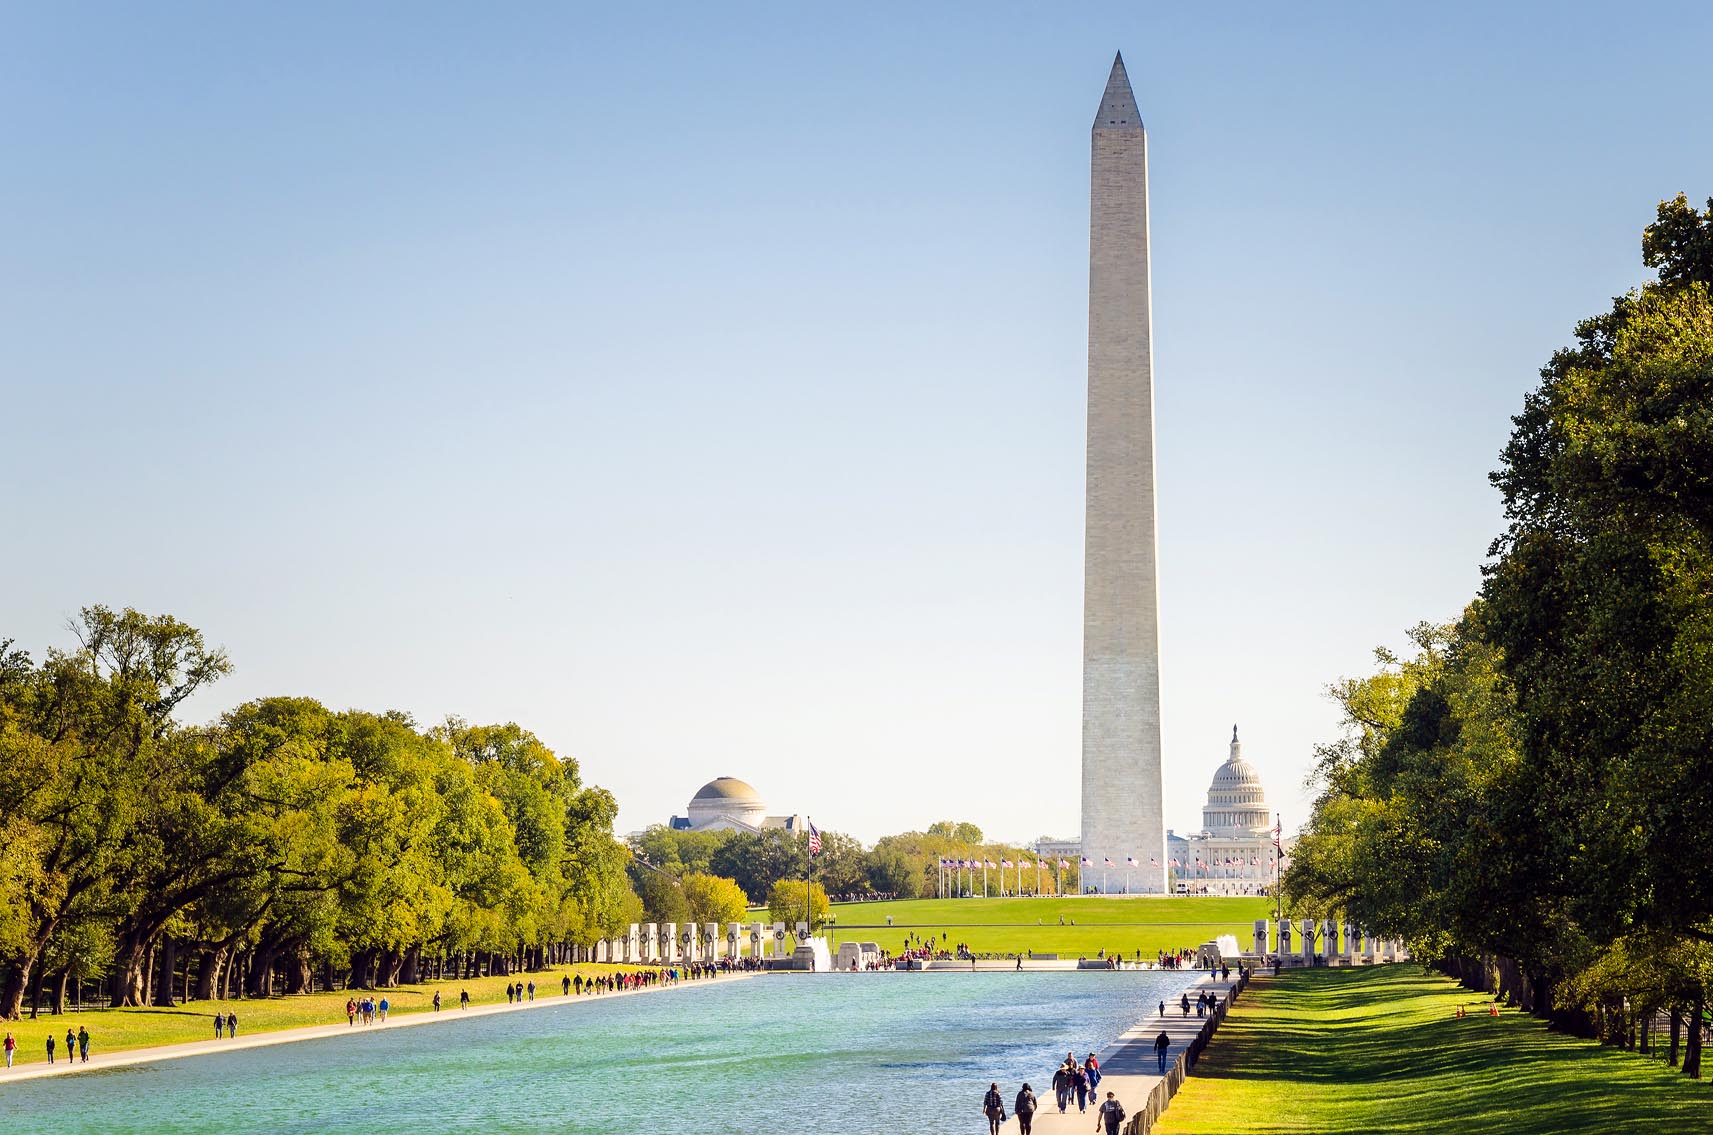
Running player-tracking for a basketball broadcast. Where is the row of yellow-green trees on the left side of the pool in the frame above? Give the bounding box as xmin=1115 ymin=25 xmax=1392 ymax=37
xmin=0 ymin=606 xmax=639 ymax=1017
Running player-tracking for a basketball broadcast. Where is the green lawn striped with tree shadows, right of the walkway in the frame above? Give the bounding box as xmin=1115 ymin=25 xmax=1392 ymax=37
xmin=1155 ymin=966 xmax=1713 ymax=1135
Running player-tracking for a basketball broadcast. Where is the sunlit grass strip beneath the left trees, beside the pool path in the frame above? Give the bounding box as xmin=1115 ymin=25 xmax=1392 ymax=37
xmin=5 ymin=966 xmax=636 ymax=1063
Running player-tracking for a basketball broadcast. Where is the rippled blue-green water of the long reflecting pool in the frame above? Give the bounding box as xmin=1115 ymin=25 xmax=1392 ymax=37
xmin=0 ymin=972 xmax=1194 ymax=1135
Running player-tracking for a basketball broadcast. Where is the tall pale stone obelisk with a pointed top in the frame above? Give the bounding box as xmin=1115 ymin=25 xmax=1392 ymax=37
xmin=1083 ymin=55 xmax=1167 ymax=894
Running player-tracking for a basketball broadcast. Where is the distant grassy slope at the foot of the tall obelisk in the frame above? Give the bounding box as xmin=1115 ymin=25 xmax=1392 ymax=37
xmin=833 ymin=897 xmax=1273 ymax=959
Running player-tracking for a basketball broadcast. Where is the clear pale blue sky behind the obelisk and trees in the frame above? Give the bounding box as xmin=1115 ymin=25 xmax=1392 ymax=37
xmin=0 ymin=3 xmax=1713 ymax=839
